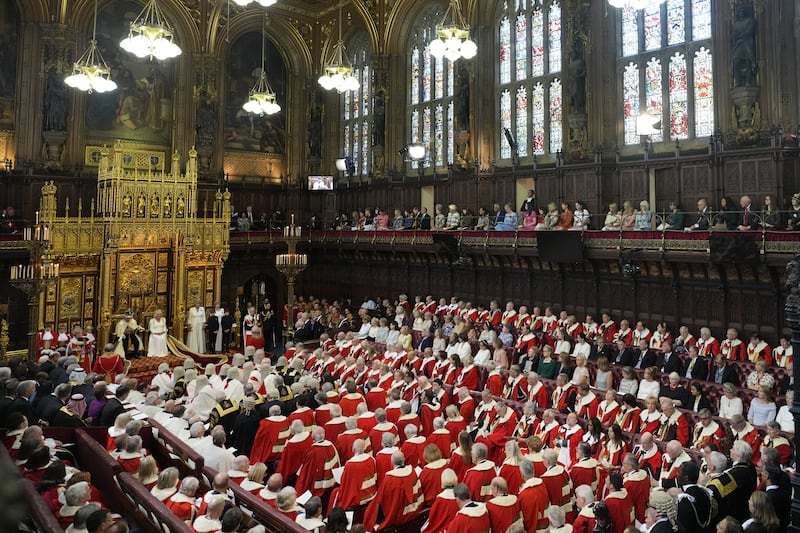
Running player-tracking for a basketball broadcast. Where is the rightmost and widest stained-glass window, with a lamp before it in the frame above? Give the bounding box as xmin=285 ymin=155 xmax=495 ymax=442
xmin=618 ymin=0 xmax=714 ymax=145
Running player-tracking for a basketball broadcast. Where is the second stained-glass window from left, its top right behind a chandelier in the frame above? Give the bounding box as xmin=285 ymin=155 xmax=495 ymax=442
xmin=408 ymin=6 xmax=456 ymax=171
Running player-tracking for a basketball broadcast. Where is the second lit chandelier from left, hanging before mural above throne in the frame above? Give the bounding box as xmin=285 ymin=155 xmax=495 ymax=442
xmin=119 ymin=0 xmax=181 ymax=61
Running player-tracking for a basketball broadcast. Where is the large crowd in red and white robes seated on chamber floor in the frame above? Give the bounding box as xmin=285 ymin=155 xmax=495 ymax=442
xmin=0 ymin=290 xmax=794 ymax=533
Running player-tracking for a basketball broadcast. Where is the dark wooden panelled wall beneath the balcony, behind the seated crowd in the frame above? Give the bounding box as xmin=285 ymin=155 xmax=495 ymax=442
xmin=286 ymin=250 xmax=788 ymax=342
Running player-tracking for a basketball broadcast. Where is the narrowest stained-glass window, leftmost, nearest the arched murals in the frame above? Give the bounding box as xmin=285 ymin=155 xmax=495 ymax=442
xmin=342 ymin=33 xmax=372 ymax=176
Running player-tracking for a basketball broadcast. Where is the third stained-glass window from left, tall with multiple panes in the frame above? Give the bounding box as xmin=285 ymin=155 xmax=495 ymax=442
xmin=497 ymin=0 xmax=564 ymax=160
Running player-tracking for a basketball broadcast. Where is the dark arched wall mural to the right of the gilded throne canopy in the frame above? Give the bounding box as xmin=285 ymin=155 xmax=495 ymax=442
xmin=225 ymin=32 xmax=286 ymax=154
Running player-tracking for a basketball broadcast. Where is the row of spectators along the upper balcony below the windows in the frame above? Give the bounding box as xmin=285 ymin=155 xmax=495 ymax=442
xmin=232 ymin=190 xmax=800 ymax=231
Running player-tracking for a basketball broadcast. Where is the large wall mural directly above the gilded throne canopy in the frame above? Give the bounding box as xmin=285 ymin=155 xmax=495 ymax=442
xmin=86 ymin=1 xmax=176 ymax=145
